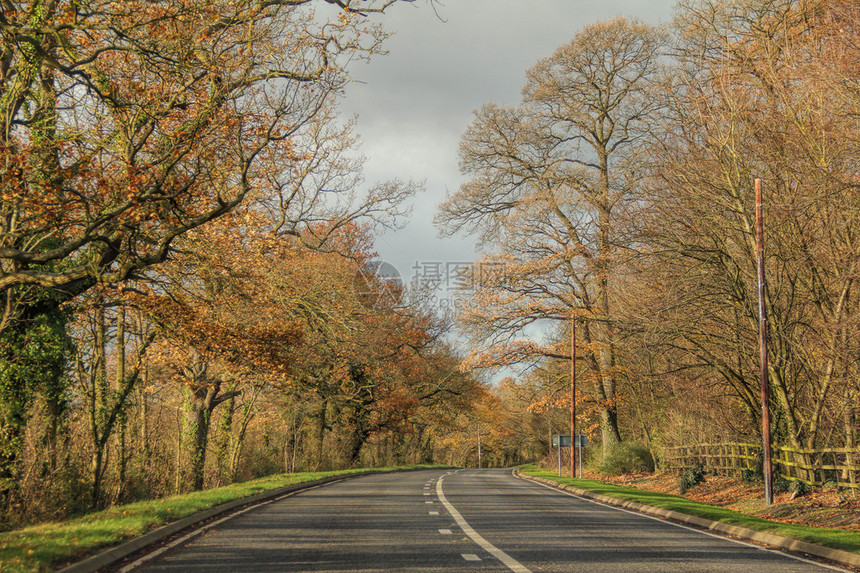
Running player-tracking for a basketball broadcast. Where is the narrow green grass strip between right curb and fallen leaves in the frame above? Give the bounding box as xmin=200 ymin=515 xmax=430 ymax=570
xmin=520 ymin=464 xmax=860 ymax=553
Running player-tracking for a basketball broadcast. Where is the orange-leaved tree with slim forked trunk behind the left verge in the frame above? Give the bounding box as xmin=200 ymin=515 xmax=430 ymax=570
xmin=135 ymin=217 xmax=352 ymax=490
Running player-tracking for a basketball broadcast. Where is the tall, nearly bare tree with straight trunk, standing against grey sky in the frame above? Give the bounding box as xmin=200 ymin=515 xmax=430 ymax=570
xmin=438 ymin=18 xmax=660 ymax=444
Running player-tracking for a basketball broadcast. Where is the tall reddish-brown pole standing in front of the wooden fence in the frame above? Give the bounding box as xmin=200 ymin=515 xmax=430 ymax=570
xmin=755 ymin=179 xmax=773 ymax=505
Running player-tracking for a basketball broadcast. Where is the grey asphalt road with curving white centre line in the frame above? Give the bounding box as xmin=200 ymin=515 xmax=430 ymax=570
xmin=133 ymin=470 xmax=848 ymax=573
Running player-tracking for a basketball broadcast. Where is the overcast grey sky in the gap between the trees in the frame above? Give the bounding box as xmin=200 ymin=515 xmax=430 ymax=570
xmin=343 ymin=0 xmax=674 ymax=288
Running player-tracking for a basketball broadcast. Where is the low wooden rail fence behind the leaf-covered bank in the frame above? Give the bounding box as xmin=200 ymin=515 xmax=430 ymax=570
xmin=659 ymin=442 xmax=860 ymax=491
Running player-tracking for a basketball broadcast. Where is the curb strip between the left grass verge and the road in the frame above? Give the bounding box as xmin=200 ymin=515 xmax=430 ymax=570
xmin=58 ymin=468 xmax=429 ymax=573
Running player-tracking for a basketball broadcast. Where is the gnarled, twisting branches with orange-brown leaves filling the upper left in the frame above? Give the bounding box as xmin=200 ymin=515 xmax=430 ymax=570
xmin=0 ymin=0 xmax=408 ymax=329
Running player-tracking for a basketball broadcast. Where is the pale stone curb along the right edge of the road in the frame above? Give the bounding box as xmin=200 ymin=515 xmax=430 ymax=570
xmin=514 ymin=469 xmax=860 ymax=567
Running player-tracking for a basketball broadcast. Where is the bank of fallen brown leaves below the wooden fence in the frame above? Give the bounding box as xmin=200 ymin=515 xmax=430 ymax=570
xmin=596 ymin=474 xmax=860 ymax=530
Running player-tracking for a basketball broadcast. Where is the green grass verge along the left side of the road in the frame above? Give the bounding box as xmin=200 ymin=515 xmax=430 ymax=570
xmin=0 ymin=466 xmax=440 ymax=573
